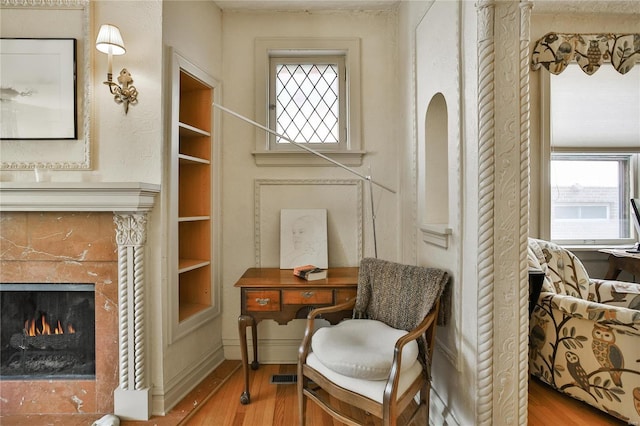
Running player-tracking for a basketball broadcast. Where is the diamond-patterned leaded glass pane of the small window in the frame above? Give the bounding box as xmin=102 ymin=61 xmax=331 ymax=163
xmin=276 ymin=64 xmax=339 ymax=143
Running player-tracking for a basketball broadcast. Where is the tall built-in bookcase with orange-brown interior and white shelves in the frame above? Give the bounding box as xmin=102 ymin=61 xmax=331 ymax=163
xmin=169 ymin=53 xmax=215 ymax=330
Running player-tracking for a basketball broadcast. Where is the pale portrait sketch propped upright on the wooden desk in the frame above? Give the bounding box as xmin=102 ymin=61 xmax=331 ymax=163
xmin=280 ymin=209 xmax=329 ymax=269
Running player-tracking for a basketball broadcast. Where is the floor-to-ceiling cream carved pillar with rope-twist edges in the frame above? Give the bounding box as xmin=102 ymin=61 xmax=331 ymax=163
xmin=476 ymin=0 xmax=531 ymax=425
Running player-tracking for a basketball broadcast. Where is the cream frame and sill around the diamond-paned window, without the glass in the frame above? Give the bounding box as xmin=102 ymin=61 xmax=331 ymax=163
xmin=253 ymin=38 xmax=365 ymax=166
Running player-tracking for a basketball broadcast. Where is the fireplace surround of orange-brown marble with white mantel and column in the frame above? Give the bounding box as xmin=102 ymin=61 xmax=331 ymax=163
xmin=0 ymin=182 xmax=160 ymax=420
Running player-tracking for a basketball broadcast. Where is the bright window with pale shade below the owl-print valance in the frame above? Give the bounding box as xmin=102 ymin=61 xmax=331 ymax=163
xmin=542 ymin=64 xmax=640 ymax=245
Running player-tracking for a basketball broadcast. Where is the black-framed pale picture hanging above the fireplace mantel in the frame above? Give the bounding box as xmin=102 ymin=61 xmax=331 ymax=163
xmin=0 ymin=38 xmax=78 ymax=140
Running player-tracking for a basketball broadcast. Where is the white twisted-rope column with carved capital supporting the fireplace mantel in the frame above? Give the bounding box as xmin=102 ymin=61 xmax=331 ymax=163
xmin=113 ymin=213 xmax=151 ymax=420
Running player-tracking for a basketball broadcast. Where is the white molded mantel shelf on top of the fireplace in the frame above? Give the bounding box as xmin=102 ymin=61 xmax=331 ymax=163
xmin=0 ymin=182 xmax=160 ymax=212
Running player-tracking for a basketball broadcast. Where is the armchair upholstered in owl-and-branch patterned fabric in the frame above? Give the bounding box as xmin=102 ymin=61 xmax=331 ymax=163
xmin=528 ymin=238 xmax=640 ymax=424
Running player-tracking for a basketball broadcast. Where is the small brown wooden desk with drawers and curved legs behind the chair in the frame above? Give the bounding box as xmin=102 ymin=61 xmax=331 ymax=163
xmin=235 ymin=267 xmax=358 ymax=404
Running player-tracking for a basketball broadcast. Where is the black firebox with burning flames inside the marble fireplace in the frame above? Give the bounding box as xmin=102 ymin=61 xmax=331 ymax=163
xmin=0 ymin=284 xmax=95 ymax=380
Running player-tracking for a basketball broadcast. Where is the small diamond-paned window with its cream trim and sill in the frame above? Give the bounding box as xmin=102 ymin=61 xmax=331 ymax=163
xmin=253 ymin=38 xmax=364 ymax=166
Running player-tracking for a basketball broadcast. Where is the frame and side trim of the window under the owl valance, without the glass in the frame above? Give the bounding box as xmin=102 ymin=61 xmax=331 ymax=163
xmin=540 ymin=66 xmax=640 ymax=248
